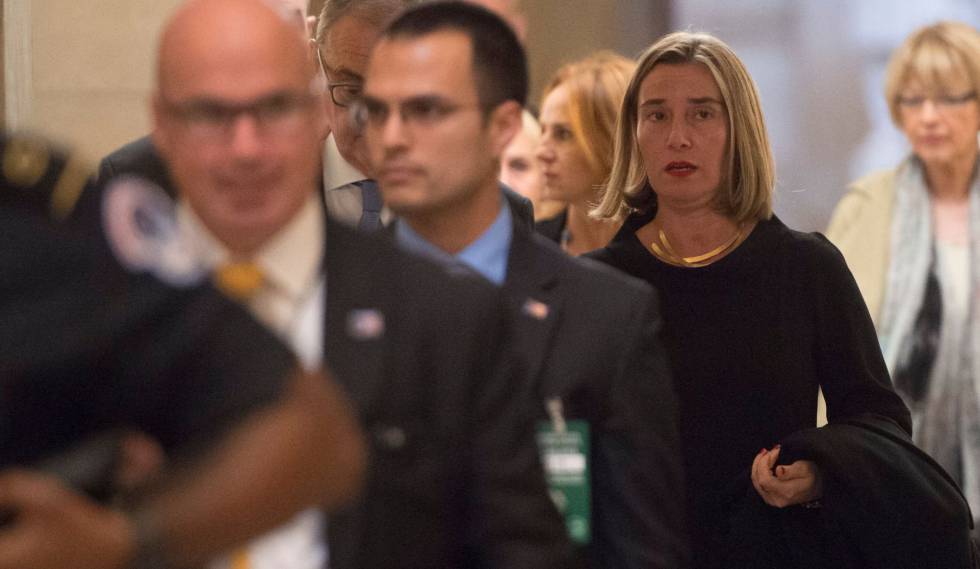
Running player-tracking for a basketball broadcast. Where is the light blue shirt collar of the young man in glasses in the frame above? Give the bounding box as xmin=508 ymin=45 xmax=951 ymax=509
xmin=395 ymin=196 xmax=513 ymax=285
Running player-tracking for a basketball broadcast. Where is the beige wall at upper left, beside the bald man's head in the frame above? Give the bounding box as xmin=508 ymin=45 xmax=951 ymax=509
xmin=3 ymin=0 xmax=179 ymax=160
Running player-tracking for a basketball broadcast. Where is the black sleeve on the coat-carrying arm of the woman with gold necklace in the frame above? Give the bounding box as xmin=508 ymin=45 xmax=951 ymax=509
xmin=808 ymin=234 xmax=912 ymax=434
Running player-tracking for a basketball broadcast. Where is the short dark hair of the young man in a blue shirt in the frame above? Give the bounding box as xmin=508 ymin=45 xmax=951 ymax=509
xmin=381 ymin=1 xmax=528 ymax=111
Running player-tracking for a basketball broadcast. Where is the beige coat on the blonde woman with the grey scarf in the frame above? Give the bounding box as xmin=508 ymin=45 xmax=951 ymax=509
xmin=827 ymin=170 xmax=895 ymax=327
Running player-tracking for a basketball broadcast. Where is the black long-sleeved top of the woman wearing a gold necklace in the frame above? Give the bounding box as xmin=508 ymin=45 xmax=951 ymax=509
xmin=590 ymin=212 xmax=911 ymax=566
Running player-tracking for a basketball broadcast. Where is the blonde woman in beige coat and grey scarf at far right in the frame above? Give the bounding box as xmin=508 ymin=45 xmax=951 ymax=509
xmin=827 ymin=22 xmax=980 ymax=537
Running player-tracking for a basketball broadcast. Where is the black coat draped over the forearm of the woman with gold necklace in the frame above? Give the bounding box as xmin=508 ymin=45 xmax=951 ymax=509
xmin=769 ymin=414 xmax=973 ymax=569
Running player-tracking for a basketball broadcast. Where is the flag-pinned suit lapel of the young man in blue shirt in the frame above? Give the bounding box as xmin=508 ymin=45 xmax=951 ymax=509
xmin=504 ymin=207 xmax=563 ymax=385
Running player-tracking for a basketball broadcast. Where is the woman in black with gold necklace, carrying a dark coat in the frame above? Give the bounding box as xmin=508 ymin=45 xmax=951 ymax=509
xmin=590 ymin=32 xmax=971 ymax=569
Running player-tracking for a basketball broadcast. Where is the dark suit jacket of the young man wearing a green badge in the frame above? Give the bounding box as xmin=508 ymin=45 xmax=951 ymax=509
xmin=504 ymin=193 xmax=687 ymax=569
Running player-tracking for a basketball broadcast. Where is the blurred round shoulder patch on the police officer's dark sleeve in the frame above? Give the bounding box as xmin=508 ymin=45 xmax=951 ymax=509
xmin=102 ymin=176 xmax=207 ymax=287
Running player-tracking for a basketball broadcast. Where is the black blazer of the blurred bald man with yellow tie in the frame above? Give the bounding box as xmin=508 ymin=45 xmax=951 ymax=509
xmin=324 ymin=222 xmax=571 ymax=569
